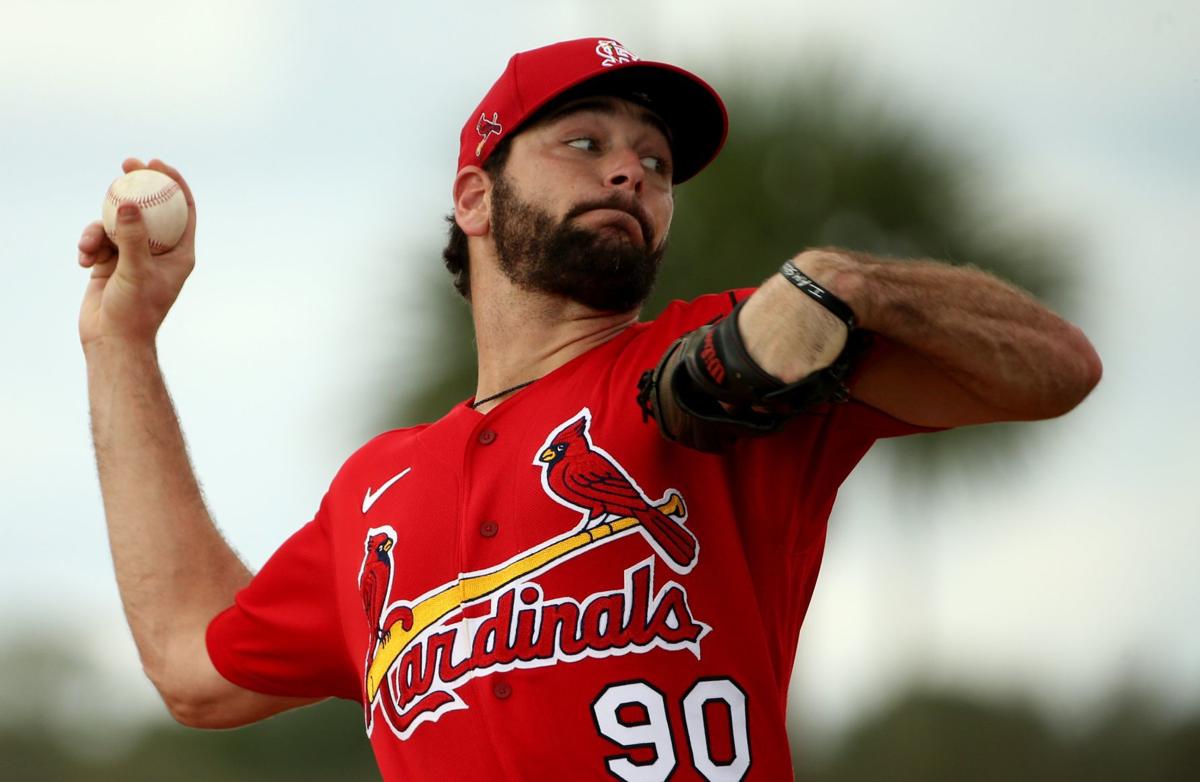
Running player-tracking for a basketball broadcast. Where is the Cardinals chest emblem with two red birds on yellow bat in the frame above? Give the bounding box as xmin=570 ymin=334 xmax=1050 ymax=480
xmin=359 ymin=408 xmax=712 ymax=741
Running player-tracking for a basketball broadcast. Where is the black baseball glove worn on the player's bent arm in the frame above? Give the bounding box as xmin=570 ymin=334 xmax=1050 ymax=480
xmin=638 ymin=302 xmax=866 ymax=452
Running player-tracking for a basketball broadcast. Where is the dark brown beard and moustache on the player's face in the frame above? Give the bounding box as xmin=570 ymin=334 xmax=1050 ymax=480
xmin=492 ymin=176 xmax=666 ymax=312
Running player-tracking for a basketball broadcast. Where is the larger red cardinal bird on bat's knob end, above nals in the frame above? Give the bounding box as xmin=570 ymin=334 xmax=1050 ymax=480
xmin=534 ymin=408 xmax=700 ymax=573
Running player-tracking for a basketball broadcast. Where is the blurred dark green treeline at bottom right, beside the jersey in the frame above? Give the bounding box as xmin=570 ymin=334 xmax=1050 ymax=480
xmin=793 ymin=684 xmax=1200 ymax=782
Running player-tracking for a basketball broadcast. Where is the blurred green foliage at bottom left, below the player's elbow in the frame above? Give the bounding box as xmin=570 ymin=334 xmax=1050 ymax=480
xmin=0 ymin=627 xmax=379 ymax=782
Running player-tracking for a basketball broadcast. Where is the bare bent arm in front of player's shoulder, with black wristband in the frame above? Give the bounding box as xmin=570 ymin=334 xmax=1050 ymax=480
xmin=742 ymin=251 xmax=1100 ymax=426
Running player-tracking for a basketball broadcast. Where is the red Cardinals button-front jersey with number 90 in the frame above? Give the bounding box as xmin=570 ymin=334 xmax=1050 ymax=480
xmin=208 ymin=291 xmax=920 ymax=782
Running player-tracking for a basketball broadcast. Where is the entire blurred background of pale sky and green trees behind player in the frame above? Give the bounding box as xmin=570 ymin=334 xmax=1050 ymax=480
xmin=0 ymin=0 xmax=1200 ymax=782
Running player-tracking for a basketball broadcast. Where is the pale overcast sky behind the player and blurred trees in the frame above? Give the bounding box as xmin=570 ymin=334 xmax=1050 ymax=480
xmin=0 ymin=0 xmax=1200 ymax=724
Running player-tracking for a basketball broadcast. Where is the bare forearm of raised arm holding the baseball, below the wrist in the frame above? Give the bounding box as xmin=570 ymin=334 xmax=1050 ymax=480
xmin=85 ymin=341 xmax=250 ymax=690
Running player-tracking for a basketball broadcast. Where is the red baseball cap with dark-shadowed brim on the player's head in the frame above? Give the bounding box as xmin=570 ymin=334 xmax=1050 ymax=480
xmin=458 ymin=38 xmax=728 ymax=184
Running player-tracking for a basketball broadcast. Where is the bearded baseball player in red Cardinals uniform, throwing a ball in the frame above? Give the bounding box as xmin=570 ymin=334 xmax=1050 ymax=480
xmin=79 ymin=38 xmax=1100 ymax=781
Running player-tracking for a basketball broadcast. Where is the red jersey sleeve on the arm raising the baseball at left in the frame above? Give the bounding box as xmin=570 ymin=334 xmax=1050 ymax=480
xmin=206 ymin=494 xmax=362 ymax=700
